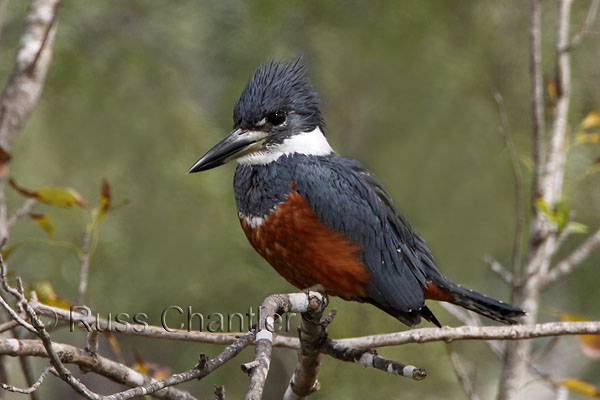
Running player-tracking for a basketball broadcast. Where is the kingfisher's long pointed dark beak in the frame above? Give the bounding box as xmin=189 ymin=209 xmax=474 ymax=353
xmin=187 ymin=129 xmax=267 ymax=174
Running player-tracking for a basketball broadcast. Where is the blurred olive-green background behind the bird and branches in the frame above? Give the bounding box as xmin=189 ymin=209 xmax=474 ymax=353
xmin=0 ymin=0 xmax=600 ymax=399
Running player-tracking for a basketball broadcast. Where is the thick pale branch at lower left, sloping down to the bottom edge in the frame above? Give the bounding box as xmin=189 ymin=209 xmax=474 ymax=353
xmin=0 ymin=338 xmax=194 ymax=400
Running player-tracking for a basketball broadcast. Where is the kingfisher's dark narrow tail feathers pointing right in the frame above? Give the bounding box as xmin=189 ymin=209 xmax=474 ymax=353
xmin=433 ymin=278 xmax=525 ymax=324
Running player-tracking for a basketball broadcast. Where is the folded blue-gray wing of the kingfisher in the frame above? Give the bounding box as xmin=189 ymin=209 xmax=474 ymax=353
xmin=293 ymin=155 xmax=437 ymax=325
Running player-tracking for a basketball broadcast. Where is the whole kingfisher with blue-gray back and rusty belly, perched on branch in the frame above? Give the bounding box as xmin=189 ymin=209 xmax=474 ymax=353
xmin=188 ymin=56 xmax=524 ymax=327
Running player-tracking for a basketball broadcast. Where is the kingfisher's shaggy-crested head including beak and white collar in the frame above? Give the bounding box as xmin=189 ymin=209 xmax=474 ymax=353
xmin=188 ymin=57 xmax=331 ymax=173
